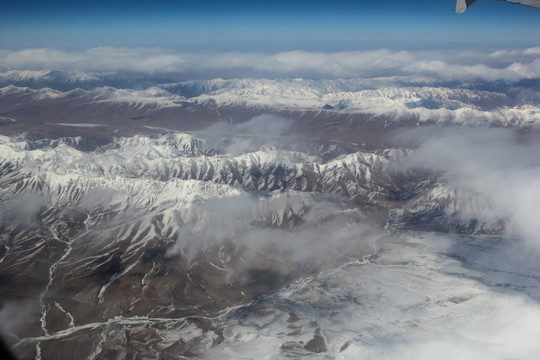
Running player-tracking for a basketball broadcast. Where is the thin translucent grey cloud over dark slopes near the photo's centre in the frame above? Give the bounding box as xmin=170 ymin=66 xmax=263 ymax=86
xmin=168 ymin=193 xmax=381 ymax=270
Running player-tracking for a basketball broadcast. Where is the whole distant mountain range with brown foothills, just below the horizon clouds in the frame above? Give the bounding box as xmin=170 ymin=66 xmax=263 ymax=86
xmin=0 ymin=70 xmax=540 ymax=142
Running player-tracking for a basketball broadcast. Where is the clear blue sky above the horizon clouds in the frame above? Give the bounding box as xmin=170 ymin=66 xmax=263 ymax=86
xmin=0 ymin=0 xmax=540 ymax=52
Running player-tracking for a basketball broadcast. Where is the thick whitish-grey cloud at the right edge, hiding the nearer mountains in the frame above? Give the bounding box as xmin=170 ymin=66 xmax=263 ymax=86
xmin=394 ymin=128 xmax=540 ymax=248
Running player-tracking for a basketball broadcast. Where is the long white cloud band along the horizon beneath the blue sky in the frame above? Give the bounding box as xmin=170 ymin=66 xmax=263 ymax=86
xmin=0 ymin=47 xmax=540 ymax=81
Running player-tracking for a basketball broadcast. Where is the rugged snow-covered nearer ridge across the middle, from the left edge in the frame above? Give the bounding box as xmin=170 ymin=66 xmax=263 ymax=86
xmin=0 ymin=133 xmax=395 ymax=207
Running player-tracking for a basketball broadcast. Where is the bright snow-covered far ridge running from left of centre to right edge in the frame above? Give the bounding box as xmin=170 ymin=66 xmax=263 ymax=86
xmin=158 ymin=79 xmax=540 ymax=126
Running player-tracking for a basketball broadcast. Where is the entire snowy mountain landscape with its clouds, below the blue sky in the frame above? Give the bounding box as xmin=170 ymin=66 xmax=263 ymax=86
xmin=0 ymin=48 xmax=540 ymax=360
